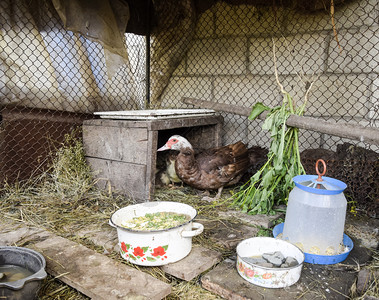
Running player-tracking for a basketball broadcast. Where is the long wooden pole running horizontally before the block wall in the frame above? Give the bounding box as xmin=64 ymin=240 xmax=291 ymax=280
xmin=182 ymin=98 xmax=379 ymax=145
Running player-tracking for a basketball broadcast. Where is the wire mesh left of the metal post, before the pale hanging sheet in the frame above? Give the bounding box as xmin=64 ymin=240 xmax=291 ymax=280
xmin=0 ymin=1 xmax=141 ymax=181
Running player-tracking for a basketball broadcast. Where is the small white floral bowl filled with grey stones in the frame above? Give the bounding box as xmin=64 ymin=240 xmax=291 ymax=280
xmin=236 ymin=237 xmax=304 ymax=288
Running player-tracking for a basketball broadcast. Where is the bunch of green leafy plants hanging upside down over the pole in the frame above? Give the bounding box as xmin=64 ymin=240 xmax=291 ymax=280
xmin=232 ymin=39 xmax=313 ymax=214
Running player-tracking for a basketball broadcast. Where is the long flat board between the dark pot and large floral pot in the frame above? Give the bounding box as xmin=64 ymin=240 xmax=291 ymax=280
xmin=33 ymin=234 xmax=171 ymax=300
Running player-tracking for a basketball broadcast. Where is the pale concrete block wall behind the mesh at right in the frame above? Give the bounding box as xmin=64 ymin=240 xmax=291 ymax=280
xmin=162 ymin=0 xmax=379 ymax=149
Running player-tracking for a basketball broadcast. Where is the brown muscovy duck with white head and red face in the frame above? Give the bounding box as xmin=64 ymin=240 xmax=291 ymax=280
xmin=158 ymin=135 xmax=267 ymax=201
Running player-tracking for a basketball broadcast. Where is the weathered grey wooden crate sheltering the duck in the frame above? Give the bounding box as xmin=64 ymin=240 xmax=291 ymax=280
xmin=83 ymin=115 xmax=223 ymax=202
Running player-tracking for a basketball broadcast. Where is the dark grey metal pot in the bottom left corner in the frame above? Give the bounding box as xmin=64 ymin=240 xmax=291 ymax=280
xmin=0 ymin=246 xmax=47 ymax=300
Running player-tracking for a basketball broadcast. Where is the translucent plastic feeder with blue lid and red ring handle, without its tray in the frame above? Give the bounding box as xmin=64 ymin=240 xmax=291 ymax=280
xmin=282 ymin=160 xmax=347 ymax=255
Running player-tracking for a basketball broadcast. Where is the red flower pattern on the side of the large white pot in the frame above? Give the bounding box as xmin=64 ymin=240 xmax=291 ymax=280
xmin=119 ymin=242 xmax=168 ymax=262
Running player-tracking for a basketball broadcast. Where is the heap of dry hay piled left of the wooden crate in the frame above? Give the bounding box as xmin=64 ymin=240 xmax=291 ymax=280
xmin=0 ymin=135 xmax=130 ymax=237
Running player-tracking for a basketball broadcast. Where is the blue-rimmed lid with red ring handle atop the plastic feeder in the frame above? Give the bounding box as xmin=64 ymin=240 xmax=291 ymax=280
xmin=293 ymin=159 xmax=347 ymax=195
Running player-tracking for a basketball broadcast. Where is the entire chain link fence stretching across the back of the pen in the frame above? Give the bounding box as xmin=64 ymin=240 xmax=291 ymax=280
xmin=0 ymin=0 xmax=379 ymax=211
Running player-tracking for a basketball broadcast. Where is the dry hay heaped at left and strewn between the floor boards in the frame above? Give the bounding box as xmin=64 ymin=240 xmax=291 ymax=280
xmin=0 ymin=133 xmax=232 ymax=300
